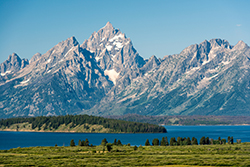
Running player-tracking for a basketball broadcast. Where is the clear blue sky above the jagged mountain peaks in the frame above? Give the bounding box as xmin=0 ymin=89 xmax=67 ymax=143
xmin=0 ymin=0 xmax=250 ymax=63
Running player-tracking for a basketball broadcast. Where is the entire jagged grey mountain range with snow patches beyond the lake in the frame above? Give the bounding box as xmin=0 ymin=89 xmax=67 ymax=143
xmin=0 ymin=22 xmax=250 ymax=118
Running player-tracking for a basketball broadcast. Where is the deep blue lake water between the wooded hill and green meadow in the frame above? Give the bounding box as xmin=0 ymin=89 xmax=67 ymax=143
xmin=0 ymin=126 xmax=250 ymax=150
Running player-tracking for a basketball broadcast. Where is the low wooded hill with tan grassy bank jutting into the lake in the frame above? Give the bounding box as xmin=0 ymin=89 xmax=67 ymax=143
xmin=0 ymin=115 xmax=167 ymax=133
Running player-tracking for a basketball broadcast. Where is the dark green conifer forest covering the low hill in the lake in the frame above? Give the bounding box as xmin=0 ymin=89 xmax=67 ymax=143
xmin=0 ymin=115 xmax=167 ymax=133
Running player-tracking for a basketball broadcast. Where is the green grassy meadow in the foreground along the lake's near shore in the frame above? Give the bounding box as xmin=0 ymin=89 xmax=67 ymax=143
xmin=0 ymin=143 xmax=250 ymax=167
